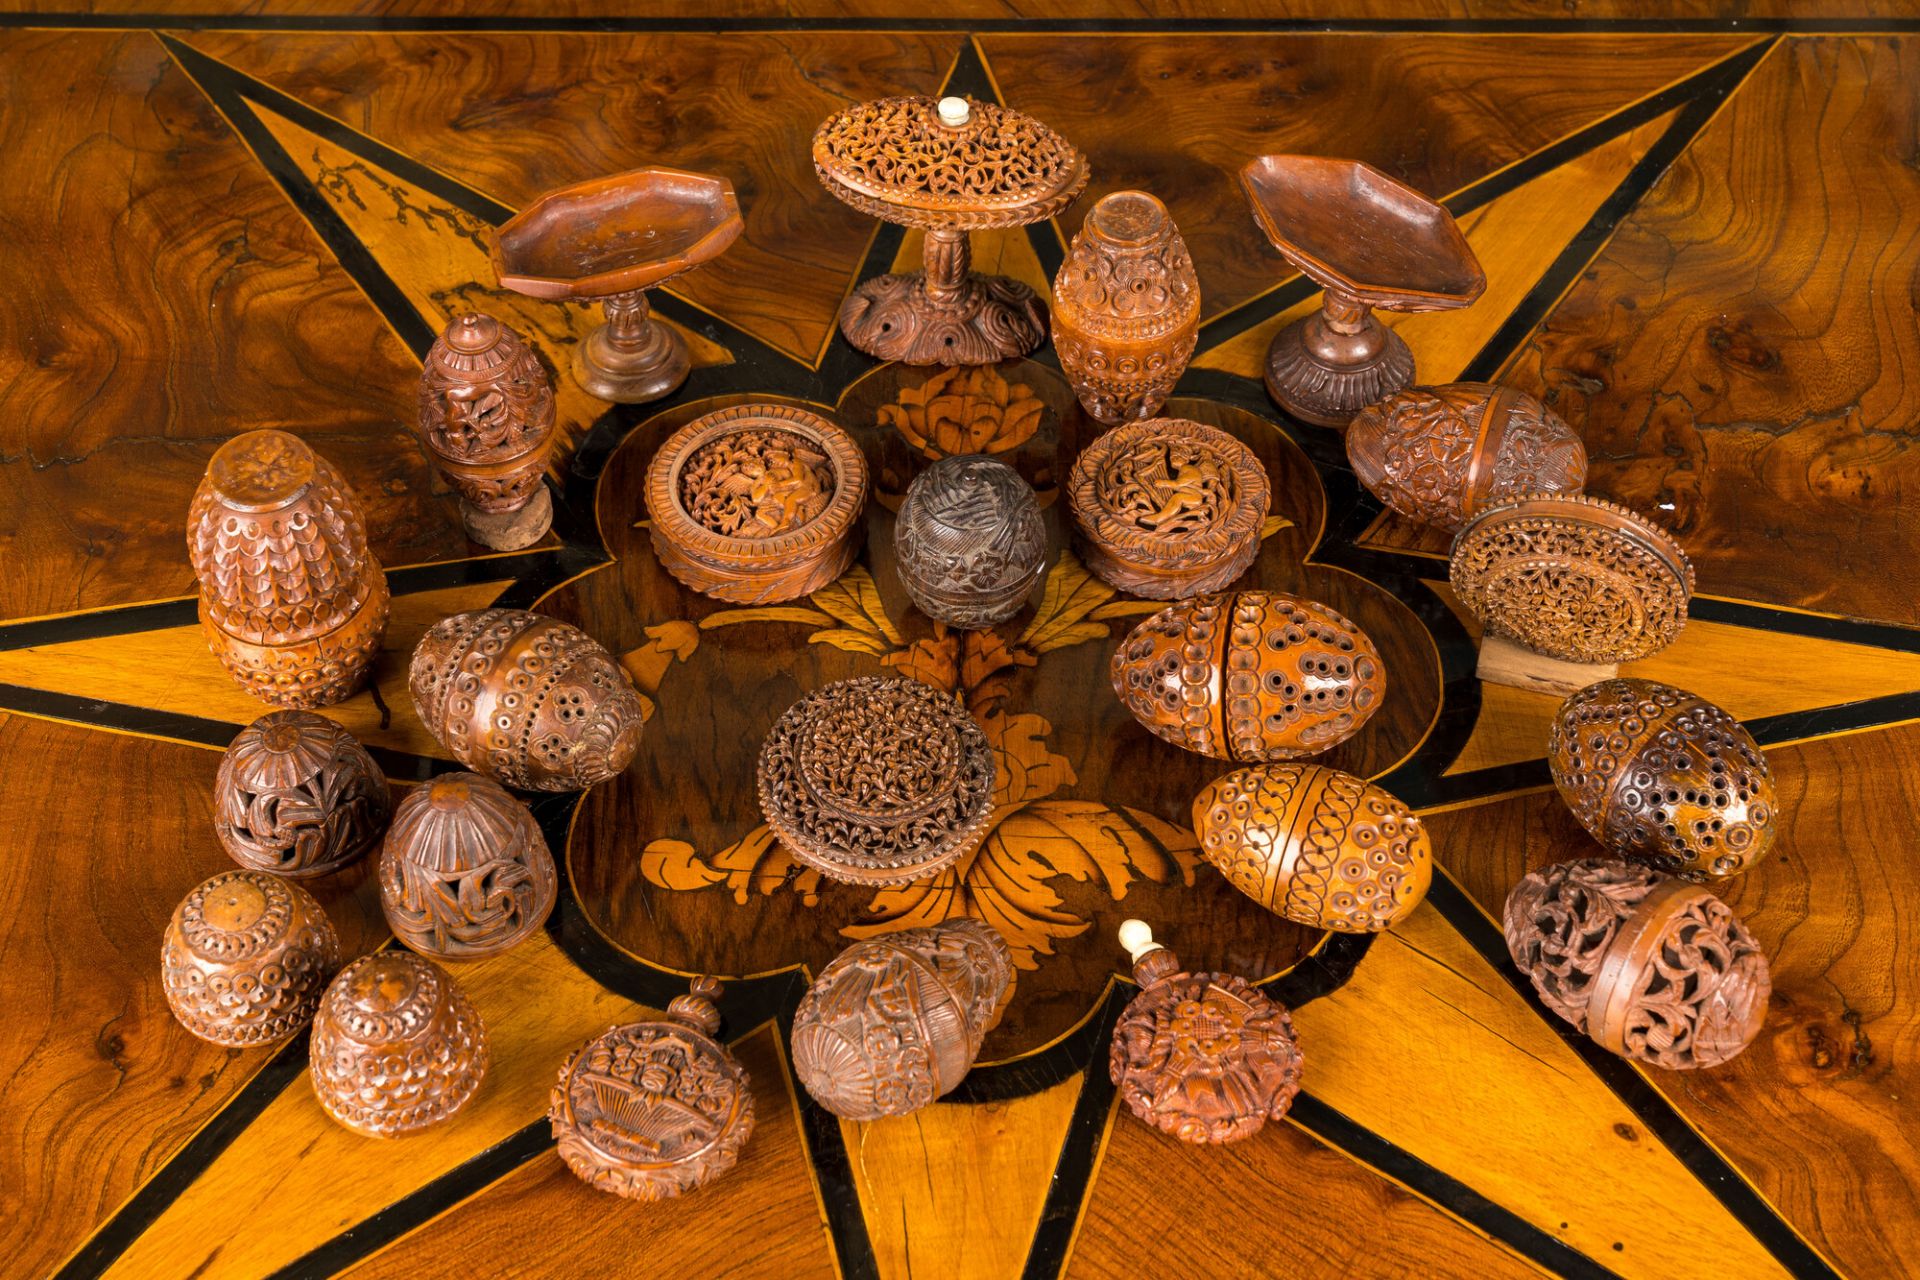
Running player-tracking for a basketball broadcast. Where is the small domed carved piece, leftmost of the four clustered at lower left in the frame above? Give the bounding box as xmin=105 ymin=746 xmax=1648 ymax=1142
xmin=159 ymin=871 xmax=340 ymax=1050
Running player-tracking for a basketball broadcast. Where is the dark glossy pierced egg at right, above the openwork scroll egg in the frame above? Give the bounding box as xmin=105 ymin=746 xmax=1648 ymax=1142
xmin=1548 ymin=677 xmax=1778 ymax=881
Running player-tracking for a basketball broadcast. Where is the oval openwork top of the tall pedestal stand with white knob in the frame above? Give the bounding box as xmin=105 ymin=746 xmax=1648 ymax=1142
xmin=814 ymin=98 xmax=1087 ymax=230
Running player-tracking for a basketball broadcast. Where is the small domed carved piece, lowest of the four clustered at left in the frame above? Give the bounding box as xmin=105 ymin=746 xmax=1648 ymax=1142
xmin=309 ymin=950 xmax=490 ymax=1138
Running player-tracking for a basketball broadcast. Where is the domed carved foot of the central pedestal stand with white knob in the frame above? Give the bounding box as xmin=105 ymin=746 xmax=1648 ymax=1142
xmin=841 ymin=271 xmax=1046 ymax=365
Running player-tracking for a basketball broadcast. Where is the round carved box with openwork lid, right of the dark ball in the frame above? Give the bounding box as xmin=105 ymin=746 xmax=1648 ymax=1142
xmin=1068 ymin=418 xmax=1269 ymax=601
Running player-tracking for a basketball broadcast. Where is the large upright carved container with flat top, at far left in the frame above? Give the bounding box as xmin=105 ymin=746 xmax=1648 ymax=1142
xmin=186 ymin=432 xmax=390 ymax=708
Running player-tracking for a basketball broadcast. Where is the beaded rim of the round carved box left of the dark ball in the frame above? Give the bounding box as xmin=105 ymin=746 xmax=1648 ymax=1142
xmin=647 ymin=405 xmax=866 ymax=578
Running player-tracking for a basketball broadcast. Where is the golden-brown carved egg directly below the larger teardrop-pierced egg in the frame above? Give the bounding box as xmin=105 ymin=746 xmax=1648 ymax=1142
xmin=1194 ymin=764 xmax=1434 ymax=933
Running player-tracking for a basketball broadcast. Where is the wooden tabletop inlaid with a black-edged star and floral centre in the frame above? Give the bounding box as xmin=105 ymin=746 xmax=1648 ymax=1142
xmin=0 ymin=0 xmax=1920 ymax=1280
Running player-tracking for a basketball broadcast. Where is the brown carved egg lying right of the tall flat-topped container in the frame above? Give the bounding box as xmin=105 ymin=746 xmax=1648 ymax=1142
xmin=407 ymin=608 xmax=645 ymax=791
